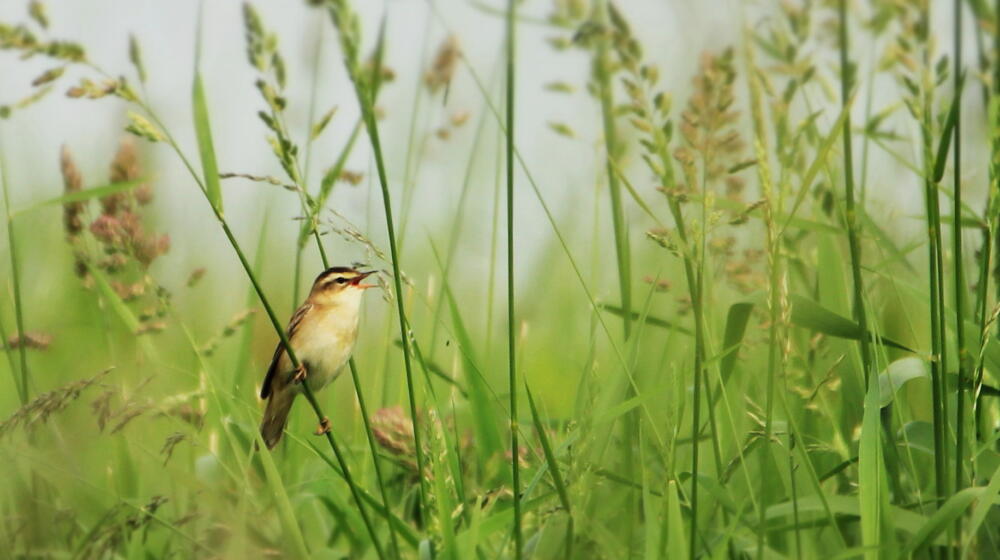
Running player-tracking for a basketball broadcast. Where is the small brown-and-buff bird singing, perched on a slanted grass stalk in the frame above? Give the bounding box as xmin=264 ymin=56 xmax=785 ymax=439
xmin=260 ymin=266 xmax=376 ymax=449
